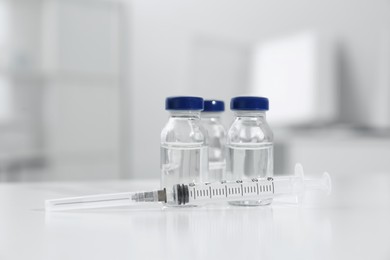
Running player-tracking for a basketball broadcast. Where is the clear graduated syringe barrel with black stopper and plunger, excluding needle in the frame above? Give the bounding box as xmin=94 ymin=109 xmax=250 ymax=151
xmin=168 ymin=172 xmax=331 ymax=206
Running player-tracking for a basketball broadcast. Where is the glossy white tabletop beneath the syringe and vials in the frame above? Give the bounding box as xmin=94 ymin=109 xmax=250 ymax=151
xmin=0 ymin=174 xmax=390 ymax=260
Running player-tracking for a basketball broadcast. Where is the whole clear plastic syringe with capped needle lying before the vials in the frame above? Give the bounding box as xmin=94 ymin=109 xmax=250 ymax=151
xmin=45 ymin=164 xmax=331 ymax=211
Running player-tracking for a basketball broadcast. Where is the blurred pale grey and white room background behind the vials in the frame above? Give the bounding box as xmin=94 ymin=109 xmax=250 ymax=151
xmin=0 ymin=0 xmax=390 ymax=182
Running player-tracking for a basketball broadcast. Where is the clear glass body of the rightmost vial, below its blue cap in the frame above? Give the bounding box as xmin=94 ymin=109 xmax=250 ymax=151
xmin=227 ymin=111 xmax=273 ymax=206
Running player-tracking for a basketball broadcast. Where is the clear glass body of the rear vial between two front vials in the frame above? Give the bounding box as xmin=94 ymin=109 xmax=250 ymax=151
xmin=201 ymin=112 xmax=226 ymax=182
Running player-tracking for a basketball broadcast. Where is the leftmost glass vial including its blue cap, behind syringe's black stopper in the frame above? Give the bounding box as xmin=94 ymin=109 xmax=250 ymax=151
xmin=160 ymin=96 xmax=208 ymax=206
